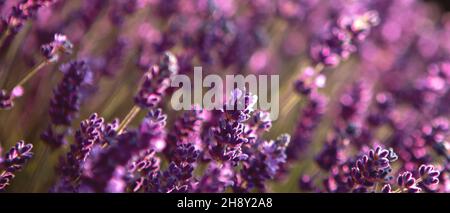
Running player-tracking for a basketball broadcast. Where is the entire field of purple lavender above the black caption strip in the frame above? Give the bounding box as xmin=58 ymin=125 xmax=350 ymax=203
xmin=0 ymin=0 xmax=450 ymax=193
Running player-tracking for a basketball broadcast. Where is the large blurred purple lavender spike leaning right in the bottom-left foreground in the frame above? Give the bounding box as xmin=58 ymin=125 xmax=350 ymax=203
xmin=82 ymin=109 xmax=166 ymax=192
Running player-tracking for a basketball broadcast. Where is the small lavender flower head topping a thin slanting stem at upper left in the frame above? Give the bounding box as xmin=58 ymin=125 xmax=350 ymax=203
xmin=41 ymin=34 xmax=73 ymax=62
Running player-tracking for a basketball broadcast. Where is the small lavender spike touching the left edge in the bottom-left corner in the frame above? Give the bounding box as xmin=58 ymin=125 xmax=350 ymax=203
xmin=0 ymin=141 xmax=33 ymax=191
